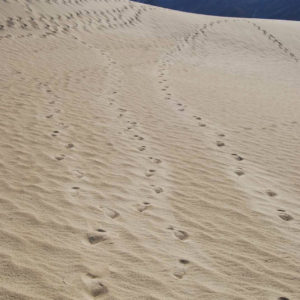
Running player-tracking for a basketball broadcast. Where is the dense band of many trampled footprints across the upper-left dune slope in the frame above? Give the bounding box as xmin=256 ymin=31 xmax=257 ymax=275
xmin=0 ymin=1 xmax=147 ymax=40
